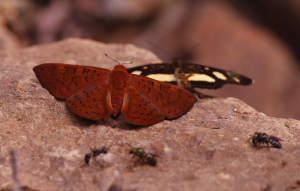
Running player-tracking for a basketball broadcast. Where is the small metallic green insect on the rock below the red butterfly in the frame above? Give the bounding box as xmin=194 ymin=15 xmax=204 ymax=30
xmin=129 ymin=148 xmax=157 ymax=166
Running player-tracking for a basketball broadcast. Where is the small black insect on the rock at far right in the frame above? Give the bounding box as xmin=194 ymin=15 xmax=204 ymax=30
xmin=251 ymin=132 xmax=282 ymax=149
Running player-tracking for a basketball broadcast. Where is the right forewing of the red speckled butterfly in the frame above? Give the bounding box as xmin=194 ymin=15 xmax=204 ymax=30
xmin=123 ymin=75 xmax=197 ymax=119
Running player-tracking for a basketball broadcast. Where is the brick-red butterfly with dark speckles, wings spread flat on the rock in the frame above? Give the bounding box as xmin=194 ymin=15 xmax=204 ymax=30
xmin=33 ymin=63 xmax=197 ymax=125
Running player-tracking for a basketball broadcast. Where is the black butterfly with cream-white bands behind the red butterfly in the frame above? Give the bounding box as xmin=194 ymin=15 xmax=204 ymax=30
xmin=127 ymin=59 xmax=254 ymax=98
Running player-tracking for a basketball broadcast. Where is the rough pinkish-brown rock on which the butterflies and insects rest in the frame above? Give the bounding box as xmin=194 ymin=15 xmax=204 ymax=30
xmin=0 ymin=39 xmax=300 ymax=191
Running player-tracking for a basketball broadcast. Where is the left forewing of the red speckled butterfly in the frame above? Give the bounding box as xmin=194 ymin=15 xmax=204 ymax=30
xmin=33 ymin=63 xmax=111 ymax=99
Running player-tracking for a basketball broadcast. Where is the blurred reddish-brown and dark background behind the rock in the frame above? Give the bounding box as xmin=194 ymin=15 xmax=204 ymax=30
xmin=0 ymin=0 xmax=300 ymax=119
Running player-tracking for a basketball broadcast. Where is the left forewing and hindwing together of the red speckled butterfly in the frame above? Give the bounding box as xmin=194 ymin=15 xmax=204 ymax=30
xmin=33 ymin=63 xmax=112 ymax=120
